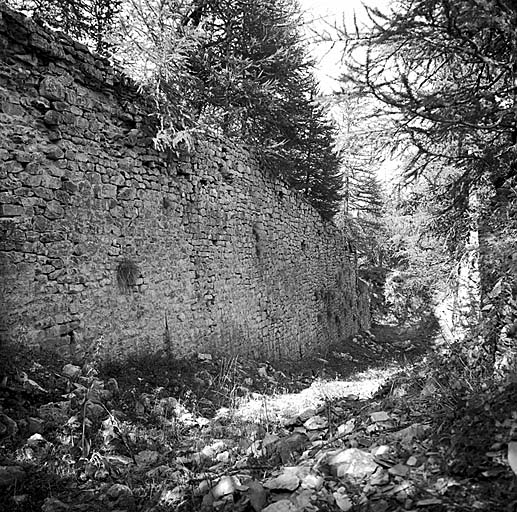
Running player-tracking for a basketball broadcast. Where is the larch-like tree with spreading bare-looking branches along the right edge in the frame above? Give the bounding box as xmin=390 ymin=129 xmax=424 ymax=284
xmin=338 ymin=0 xmax=517 ymax=374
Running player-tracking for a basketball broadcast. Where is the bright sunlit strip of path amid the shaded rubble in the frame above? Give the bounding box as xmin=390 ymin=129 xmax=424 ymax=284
xmin=234 ymin=367 xmax=400 ymax=424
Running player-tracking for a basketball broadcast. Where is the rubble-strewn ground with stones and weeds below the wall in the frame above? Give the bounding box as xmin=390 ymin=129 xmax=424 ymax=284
xmin=0 ymin=325 xmax=517 ymax=512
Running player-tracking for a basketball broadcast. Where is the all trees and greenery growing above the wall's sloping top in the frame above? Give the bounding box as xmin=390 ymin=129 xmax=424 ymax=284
xmin=9 ymin=0 xmax=342 ymax=220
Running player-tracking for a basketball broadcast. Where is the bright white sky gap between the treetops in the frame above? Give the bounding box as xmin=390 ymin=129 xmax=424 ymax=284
xmin=299 ymin=0 xmax=390 ymax=93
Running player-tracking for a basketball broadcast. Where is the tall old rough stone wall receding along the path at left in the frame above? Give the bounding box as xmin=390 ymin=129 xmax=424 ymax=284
xmin=0 ymin=7 xmax=368 ymax=364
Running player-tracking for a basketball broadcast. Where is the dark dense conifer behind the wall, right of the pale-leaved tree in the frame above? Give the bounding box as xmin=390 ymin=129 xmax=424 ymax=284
xmin=153 ymin=0 xmax=342 ymax=219
